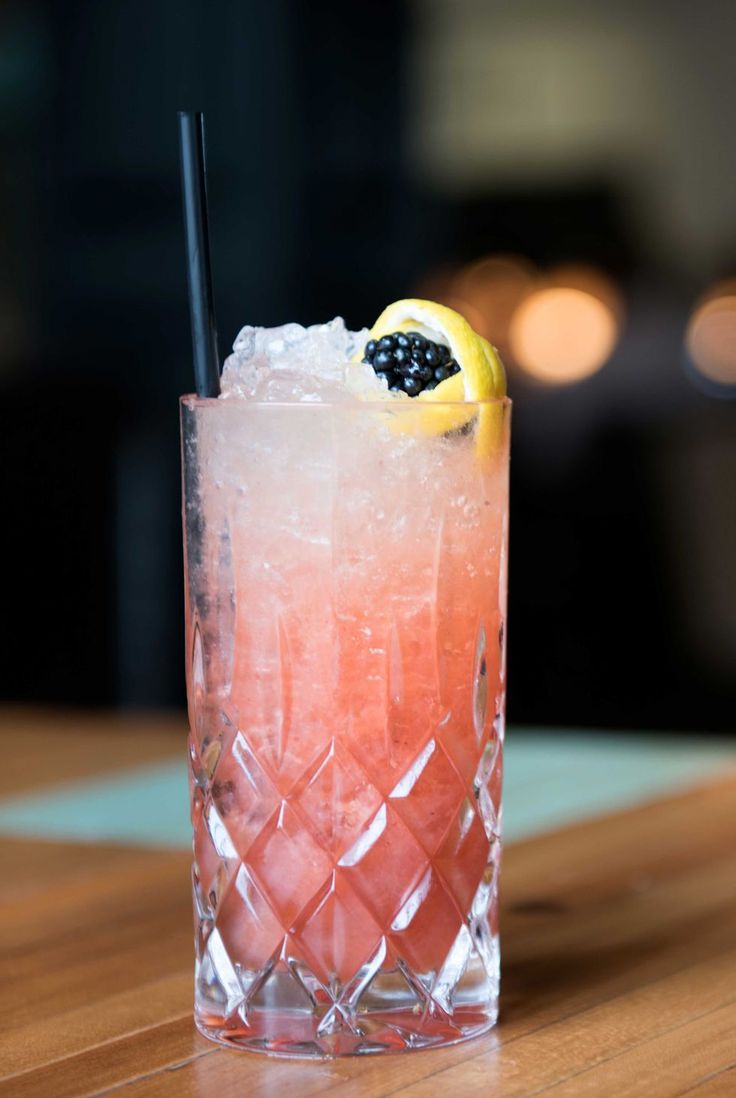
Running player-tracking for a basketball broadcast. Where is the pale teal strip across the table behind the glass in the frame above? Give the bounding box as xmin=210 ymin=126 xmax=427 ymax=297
xmin=0 ymin=728 xmax=736 ymax=849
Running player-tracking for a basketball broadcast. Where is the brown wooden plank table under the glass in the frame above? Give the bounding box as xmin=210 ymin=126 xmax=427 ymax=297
xmin=0 ymin=715 xmax=736 ymax=1098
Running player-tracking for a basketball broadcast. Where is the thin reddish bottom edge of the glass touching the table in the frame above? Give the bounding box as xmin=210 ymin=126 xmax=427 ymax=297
xmin=194 ymin=1008 xmax=498 ymax=1060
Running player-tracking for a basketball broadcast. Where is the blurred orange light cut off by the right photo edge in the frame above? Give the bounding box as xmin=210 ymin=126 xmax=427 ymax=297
xmin=685 ymin=279 xmax=736 ymax=385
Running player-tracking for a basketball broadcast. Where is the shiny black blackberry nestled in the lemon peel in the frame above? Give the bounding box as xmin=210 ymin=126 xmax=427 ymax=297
xmin=363 ymin=332 xmax=460 ymax=396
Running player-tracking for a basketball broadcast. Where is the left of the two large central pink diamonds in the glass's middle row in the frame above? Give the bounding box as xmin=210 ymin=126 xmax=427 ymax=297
xmin=247 ymin=800 xmax=332 ymax=928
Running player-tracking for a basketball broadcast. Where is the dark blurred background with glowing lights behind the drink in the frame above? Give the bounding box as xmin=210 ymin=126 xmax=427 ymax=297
xmin=0 ymin=0 xmax=736 ymax=731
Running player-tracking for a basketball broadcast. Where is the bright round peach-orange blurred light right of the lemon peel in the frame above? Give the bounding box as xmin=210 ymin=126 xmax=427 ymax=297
xmin=510 ymin=285 xmax=618 ymax=384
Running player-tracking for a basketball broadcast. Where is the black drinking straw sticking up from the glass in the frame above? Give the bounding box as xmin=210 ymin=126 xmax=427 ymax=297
xmin=179 ymin=111 xmax=220 ymax=396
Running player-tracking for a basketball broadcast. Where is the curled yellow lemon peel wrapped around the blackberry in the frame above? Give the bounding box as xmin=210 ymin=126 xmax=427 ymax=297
xmin=358 ymin=298 xmax=506 ymax=455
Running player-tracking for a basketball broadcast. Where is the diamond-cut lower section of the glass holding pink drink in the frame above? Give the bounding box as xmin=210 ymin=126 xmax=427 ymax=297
xmin=194 ymin=698 xmax=501 ymax=1054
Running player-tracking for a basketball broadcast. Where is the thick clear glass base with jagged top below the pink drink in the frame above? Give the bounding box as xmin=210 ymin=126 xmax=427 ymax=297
xmin=194 ymin=923 xmax=499 ymax=1060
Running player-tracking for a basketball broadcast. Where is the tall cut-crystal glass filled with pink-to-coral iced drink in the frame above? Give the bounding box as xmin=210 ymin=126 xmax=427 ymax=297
xmin=181 ymin=397 xmax=510 ymax=1057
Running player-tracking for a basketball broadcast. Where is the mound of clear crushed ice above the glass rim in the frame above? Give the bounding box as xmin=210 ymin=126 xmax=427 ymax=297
xmin=221 ymin=316 xmax=406 ymax=402
